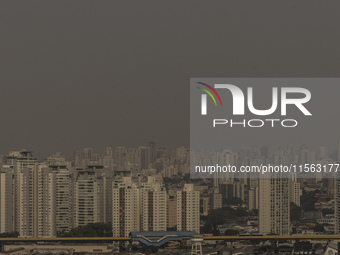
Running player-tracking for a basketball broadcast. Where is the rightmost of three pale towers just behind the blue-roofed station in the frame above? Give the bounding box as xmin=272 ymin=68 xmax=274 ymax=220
xmin=177 ymin=184 xmax=200 ymax=233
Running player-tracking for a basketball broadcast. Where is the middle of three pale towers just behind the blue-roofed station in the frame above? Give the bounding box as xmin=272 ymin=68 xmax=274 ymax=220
xmin=141 ymin=176 xmax=167 ymax=231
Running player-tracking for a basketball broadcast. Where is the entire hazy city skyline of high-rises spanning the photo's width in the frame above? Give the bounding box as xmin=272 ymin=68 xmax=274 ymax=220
xmin=0 ymin=142 xmax=339 ymax=246
